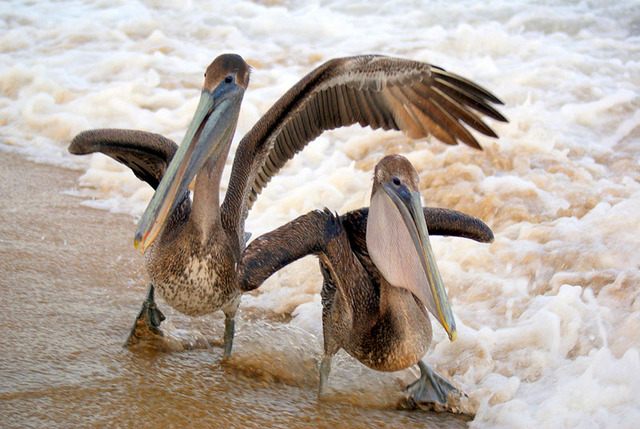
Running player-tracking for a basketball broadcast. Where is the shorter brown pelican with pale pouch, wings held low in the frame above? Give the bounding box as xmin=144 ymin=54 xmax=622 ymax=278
xmin=238 ymin=155 xmax=493 ymax=407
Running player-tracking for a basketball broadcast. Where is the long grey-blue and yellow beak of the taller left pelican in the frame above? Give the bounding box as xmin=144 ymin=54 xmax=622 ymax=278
xmin=133 ymin=84 xmax=244 ymax=253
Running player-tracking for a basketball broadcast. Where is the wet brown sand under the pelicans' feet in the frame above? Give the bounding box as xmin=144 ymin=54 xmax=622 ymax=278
xmin=0 ymin=152 xmax=466 ymax=428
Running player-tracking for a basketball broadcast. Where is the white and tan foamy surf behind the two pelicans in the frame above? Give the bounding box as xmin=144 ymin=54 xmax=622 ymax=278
xmin=0 ymin=0 xmax=640 ymax=427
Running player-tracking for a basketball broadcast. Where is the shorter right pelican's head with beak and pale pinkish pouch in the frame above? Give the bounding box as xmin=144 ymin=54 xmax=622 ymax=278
xmin=366 ymin=155 xmax=456 ymax=341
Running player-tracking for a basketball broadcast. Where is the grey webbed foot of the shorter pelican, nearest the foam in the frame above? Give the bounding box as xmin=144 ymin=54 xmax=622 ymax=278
xmin=405 ymin=360 xmax=467 ymax=412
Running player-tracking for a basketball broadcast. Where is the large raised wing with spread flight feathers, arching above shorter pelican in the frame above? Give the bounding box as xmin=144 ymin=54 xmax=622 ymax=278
xmin=223 ymin=55 xmax=506 ymax=246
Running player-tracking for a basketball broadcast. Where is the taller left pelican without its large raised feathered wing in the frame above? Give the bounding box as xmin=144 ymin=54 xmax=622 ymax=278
xmin=69 ymin=55 xmax=249 ymax=352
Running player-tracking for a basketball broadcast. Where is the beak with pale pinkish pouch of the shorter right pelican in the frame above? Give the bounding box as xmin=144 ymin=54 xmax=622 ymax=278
xmin=367 ymin=182 xmax=457 ymax=341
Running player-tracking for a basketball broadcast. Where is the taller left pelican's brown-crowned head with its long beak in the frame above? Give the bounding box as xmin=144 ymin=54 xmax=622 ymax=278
xmin=134 ymin=54 xmax=249 ymax=253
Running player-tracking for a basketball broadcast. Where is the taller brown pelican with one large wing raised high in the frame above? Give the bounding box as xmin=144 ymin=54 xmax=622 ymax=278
xmin=69 ymin=54 xmax=505 ymax=356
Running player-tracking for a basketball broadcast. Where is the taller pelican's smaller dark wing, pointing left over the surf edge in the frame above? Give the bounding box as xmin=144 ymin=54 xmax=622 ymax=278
xmin=69 ymin=128 xmax=178 ymax=189
